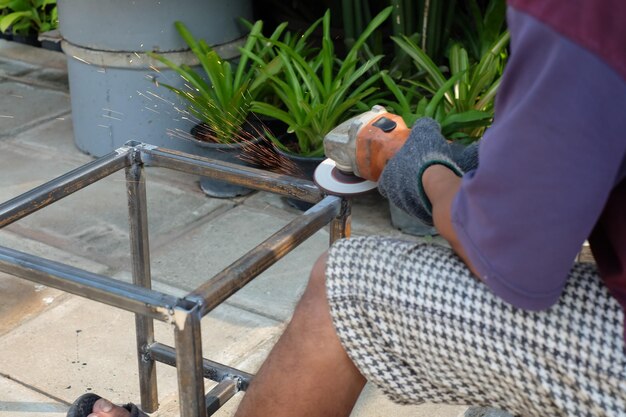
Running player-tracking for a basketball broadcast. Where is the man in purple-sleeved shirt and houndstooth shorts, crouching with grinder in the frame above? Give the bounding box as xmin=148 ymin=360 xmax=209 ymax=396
xmin=68 ymin=0 xmax=626 ymax=417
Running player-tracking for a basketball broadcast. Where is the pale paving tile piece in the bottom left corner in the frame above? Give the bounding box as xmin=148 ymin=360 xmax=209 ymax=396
xmin=0 ymin=376 xmax=68 ymax=417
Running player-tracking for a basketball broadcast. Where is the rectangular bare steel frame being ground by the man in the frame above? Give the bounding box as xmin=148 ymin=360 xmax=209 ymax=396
xmin=0 ymin=142 xmax=351 ymax=417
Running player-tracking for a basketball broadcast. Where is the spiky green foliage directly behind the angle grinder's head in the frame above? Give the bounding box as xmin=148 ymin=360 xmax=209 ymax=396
xmin=248 ymin=8 xmax=391 ymax=156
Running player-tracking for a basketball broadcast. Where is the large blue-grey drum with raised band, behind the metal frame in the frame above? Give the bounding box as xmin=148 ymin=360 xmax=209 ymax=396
xmin=58 ymin=0 xmax=252 ymax=156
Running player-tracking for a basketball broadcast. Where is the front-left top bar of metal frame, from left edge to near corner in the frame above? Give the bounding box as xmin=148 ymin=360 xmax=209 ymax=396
xmin=0 ymin=246 xmax=182 ymax=322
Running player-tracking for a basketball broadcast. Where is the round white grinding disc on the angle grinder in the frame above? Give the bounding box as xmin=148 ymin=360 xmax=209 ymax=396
xmin=313 ymin=158 xmax=378 ymax=196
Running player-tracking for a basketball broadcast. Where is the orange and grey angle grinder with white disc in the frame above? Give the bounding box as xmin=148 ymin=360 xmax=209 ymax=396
xmin=313 ymin=106 xmax=410 ymax=196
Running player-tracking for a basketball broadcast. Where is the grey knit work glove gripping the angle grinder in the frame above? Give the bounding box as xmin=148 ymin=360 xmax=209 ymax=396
xmin=378 ymin=118 xmax=478 ymax=226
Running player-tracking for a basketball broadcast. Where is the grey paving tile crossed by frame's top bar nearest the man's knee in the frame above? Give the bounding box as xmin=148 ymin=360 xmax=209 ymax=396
xmin=152 ymin=206 xmax=328 ymax=320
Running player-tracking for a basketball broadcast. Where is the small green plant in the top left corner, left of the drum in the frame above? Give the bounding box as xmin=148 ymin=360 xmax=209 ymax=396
xmin=0 ymin=0 xmax=58 ymax=35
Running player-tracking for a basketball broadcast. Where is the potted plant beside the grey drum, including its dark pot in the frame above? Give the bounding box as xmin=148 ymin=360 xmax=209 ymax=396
xmin=148 ymin=21 xmax=280 ymax=197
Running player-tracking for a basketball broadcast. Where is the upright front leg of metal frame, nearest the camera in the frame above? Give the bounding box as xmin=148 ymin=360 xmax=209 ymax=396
xmin=174 ymin=305 xmax=207 ymax=417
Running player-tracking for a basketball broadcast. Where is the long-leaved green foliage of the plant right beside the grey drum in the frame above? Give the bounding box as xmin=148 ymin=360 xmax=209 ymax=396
xmin=149 ymin=21 xmax=269 ymax=143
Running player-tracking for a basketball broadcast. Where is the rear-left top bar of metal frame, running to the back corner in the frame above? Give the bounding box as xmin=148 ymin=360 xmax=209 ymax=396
xmin=0 ymin=147 xmax=131 ymax=228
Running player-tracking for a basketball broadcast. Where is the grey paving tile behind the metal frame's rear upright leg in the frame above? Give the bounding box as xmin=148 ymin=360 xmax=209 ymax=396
xmin=0 ymin=142 xmax=233 ymax=267
